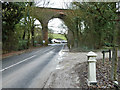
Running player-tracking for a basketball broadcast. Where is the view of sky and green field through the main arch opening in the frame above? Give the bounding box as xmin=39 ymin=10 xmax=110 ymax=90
xmin=48 ymin=18 xmax=68 ymax=43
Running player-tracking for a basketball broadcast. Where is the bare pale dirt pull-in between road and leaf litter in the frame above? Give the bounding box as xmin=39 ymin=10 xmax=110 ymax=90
xmin=44 ymin=52 xmax=87 ymax=88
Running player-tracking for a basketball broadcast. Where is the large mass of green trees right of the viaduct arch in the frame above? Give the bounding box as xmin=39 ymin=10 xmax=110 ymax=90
xmin=66 ymin=2 xmax=116 ymax=50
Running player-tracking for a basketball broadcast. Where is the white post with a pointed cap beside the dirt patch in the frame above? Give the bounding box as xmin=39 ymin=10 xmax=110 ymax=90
xmin=87 ymin=51 xmax=97 ymax=86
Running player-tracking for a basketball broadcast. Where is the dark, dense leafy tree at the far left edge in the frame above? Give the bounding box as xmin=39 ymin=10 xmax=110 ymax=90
xmin=2 ymin=2 xmax=25 ymax=51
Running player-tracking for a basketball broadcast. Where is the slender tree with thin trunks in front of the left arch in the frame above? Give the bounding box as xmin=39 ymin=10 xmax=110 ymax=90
xmin=23 ymin=2 xmax=36 ymax=48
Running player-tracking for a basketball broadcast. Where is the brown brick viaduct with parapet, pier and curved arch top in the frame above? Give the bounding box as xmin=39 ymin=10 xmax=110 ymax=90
xmin=31 ymin=7 xmax=72 ymax=45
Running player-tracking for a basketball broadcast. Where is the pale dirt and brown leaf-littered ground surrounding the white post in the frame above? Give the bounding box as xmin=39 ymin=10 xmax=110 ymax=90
xmin=44 ymin=52 xmax=120 ymax=88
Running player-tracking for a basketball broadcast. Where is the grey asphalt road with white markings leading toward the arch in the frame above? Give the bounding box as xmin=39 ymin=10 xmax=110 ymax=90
xmin=1 ymin=45 xmax=64 ymax=88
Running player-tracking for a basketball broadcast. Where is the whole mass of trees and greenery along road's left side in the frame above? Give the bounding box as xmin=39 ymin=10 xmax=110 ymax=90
xmin=2 ymin=2 xmax=42 ymax=53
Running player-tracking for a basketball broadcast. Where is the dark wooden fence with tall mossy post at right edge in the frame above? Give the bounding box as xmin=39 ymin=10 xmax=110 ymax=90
xmin=102 ymin=46 xmax=120 ymax=88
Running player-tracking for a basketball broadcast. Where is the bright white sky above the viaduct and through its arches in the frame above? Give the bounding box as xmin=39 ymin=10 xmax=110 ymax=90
xmin=35 ymin=0 xmax=72 ymax=33
